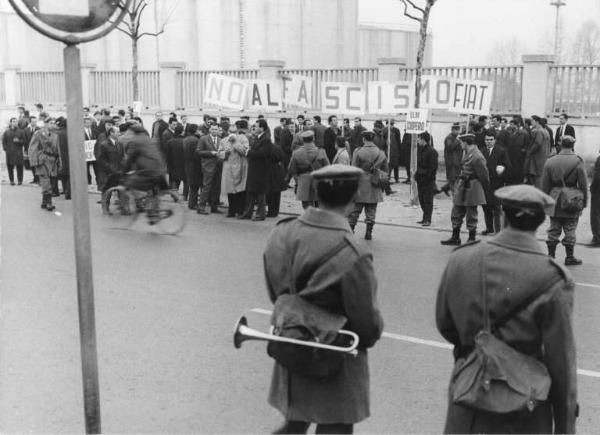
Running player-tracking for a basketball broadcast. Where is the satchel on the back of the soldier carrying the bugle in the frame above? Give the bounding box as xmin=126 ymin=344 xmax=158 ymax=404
xmin=267 ymin=241 xmax=347 ymax=379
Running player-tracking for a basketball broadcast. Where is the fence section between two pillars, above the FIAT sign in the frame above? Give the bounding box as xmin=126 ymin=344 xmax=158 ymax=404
xmin=400 ymin=66 xmax=523 ymax=113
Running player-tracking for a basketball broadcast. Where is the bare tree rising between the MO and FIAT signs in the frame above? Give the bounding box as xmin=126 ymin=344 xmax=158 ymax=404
xmin=400 ymin=0 xmax=437 ymax=206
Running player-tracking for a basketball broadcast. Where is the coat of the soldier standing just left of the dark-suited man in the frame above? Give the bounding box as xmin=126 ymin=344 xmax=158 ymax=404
xmin=453 ymin=146 xmax=490 ymax=207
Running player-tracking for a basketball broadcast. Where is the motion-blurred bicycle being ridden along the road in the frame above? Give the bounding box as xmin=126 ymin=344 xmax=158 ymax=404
xmin=102 ymin=174 xmax=185 ymax=235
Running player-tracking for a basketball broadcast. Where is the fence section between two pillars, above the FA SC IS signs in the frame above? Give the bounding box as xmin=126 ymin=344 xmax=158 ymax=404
xmin=281 ymin=68 xmax=379 ymax=110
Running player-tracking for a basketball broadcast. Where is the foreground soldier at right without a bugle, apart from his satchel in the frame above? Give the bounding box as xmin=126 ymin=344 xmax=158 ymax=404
xmin=436 ymin=185 xmax=577 ymax=434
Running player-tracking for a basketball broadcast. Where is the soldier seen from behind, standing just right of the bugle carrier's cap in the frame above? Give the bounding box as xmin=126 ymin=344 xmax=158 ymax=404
xmin=348 ymin=131 xmax=389 ymax=240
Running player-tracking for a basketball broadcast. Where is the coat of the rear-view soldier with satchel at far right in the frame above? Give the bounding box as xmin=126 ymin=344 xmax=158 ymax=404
xmin=542 ymin=148 xmax=588 ymax=218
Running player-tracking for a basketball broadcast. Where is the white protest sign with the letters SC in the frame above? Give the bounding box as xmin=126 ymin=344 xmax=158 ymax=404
xmin=321 ymin=82 xmax=366 ymax=115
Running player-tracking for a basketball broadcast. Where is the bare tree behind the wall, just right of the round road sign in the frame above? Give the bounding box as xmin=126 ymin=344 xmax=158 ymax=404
xmin=111 ymin=0 xmax=178 ymax=101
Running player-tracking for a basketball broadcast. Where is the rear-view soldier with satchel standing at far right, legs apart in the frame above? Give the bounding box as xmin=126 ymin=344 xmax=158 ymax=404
xmin=542 ymin=136 xmax=588 ymax=266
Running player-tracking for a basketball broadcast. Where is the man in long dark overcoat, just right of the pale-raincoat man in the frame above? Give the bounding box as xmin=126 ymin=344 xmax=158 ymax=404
xmin=239 ymin=119 xmax=271 ymax=221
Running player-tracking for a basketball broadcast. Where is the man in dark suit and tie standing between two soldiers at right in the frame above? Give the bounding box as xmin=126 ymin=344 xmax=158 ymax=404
xmin=481 ymin=129 xmax=511 ymax=236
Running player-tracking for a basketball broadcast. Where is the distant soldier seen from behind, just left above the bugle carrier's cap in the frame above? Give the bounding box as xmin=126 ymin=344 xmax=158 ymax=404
xmin=288 ymin=130 xmax=329 ymax=208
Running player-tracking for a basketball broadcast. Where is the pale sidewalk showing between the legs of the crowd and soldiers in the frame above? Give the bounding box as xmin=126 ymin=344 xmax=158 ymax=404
xmin=0 ymin=164 xmax=592 ymax=245
